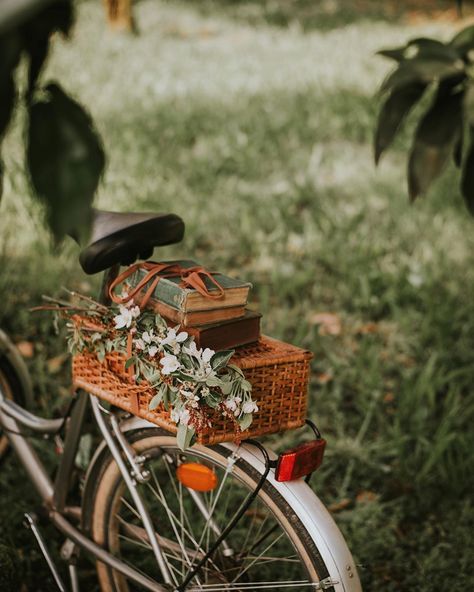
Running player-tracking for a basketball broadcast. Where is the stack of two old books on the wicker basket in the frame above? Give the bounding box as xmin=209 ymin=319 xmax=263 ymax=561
xmin=132 ymin=260 xmax=261 ymax=350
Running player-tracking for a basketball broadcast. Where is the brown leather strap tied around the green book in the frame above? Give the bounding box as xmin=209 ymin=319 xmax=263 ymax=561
xmin=109 ymin=261 xmax=224 ymax=307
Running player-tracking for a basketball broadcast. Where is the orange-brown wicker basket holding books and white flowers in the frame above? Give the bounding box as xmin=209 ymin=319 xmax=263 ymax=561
xmin=73 ymin=337 xmax=312 ymax=444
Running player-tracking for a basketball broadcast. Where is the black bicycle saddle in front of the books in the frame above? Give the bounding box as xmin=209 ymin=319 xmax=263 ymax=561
xmin=72 ymin=209 xmax=184 ymax=274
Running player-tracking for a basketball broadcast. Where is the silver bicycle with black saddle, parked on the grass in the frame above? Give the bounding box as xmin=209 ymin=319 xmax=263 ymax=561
xmin=0 ymin=210 xmax=361 ymax=592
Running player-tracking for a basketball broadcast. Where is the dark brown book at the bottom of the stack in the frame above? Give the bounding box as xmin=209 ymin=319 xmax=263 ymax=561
xmin=186 ymin=310 xmax=262 ymax=351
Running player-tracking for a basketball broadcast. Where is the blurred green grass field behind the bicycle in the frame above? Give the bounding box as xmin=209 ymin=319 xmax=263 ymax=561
xmin=0 ymin=0 xmax=474 ymax=592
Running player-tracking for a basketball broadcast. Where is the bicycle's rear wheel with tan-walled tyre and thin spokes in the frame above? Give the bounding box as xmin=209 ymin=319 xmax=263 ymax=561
xmin=86 ymin=429 xmax=332 ymax=592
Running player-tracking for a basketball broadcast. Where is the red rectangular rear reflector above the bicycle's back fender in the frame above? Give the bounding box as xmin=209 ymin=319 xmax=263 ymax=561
xmin=275 ymin=438 xmax=326 ymax=481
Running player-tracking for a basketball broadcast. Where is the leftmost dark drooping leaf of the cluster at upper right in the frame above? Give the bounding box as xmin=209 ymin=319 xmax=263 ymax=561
xmin=375 ymin=82 xmax=426 ymax=164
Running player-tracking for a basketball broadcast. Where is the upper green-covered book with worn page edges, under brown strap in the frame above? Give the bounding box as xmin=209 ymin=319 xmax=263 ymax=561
xmin=132 ymin=259 xmax=252 ymax=311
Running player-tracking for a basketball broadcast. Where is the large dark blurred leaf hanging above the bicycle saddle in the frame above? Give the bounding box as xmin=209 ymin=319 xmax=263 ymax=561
xmin=27 ymin=84 xmax=105 ymax=241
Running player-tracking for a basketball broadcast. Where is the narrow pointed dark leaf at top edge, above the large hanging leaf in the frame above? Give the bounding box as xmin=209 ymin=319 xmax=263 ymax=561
xmin=21 ymin=0 xmax=74 ymax=95
